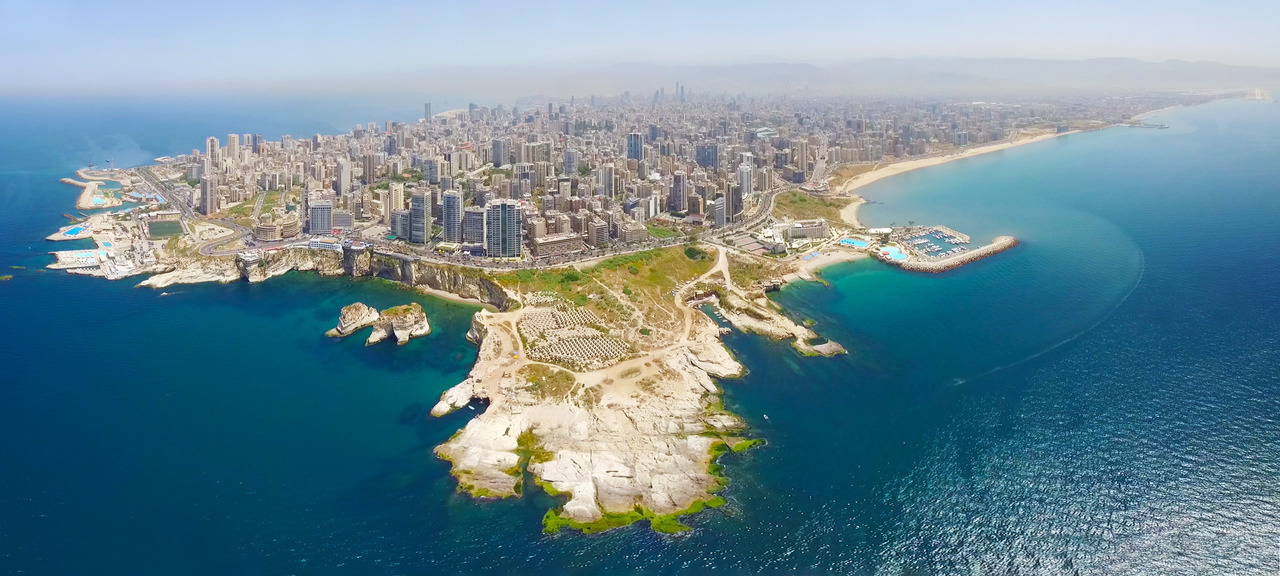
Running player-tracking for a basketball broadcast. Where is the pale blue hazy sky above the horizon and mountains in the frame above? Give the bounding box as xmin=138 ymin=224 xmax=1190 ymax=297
xmin=0 ymin=0 xmax=1280 ymax=92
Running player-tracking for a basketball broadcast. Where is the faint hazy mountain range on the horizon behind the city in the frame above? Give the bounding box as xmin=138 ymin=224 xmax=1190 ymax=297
xmin=386 ymin=58 xmax=1280 ymax=100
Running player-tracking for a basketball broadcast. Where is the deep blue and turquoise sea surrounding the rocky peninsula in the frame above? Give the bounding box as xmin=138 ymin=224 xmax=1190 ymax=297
xmin=0 ymin=92 xmax=1280 ymax=576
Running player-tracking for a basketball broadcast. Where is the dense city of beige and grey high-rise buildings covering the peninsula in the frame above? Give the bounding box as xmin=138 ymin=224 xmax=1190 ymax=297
xmin=173 ymin=91 xmax=1177 ymax=259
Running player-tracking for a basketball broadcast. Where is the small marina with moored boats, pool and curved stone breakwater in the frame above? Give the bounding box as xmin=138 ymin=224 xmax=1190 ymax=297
xmin=836 ymin=225 xmax=1018 ymax=273
